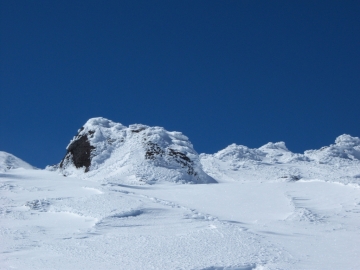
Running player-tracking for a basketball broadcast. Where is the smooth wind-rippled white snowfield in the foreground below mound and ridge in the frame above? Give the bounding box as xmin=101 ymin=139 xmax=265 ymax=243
xmin=0 ymin=168 xmax=360 ymax=270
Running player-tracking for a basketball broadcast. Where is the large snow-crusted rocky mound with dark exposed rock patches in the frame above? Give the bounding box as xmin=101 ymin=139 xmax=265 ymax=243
xmin=52 ymin=117 xmax=216 ymax=184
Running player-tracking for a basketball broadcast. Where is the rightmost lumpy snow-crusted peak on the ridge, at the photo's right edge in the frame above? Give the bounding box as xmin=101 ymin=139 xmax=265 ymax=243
xmin=305 ymin=134 xmax=360 ymax=164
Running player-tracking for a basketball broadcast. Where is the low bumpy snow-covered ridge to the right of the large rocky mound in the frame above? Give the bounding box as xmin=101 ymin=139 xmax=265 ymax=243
xmin=200 ymin=134 xmax=360 ymax=185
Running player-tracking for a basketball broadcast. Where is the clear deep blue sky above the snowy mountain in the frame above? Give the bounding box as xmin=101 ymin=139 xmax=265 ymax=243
xmin=0 ymin=0 xmax=360 ymax=167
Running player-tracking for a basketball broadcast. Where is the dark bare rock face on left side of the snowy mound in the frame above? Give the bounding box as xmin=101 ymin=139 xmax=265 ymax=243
xmin=60 ymin=132 xmax=95 ymax=172
